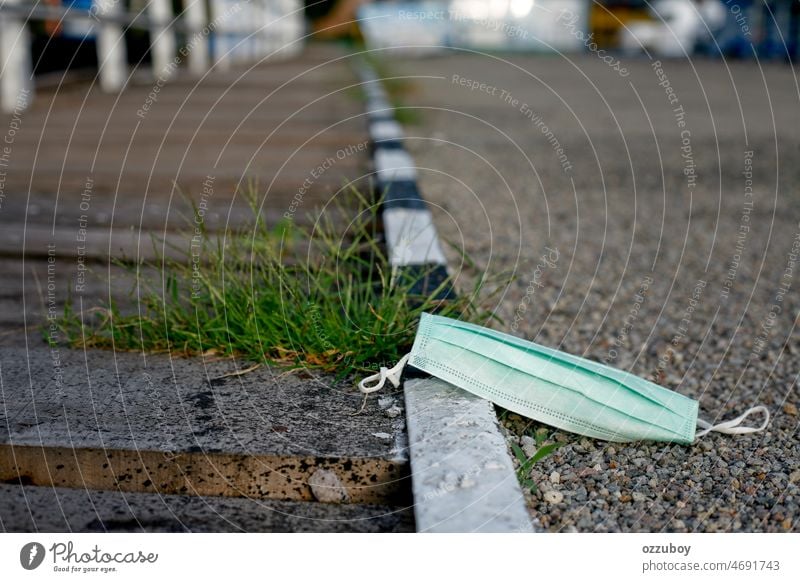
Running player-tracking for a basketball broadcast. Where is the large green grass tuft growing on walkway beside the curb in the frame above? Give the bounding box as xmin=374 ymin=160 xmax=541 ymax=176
xmin=50 ymin=190 xmax=491 ymax=379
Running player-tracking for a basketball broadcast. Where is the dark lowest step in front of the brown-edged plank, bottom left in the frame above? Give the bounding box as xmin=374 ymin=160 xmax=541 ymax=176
xmin=0 ymin=485 xmax=414 ymax=533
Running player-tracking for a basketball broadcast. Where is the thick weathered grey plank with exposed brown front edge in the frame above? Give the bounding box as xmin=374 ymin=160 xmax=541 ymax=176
xmin=0 ymin=348 xmax=409 ymax=504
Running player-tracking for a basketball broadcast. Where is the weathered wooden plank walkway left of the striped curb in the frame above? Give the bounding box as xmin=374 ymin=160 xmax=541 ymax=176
xmin=0 ymin=45 xmax=413 ymax=531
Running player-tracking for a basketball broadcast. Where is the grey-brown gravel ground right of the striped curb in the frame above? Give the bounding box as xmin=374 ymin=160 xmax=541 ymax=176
xmin=396 ymin=54 xmax=800 ymax=532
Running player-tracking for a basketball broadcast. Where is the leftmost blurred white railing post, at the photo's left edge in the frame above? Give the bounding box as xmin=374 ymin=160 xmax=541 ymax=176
xmin=0 ymin=0 xmax=33 ymax=113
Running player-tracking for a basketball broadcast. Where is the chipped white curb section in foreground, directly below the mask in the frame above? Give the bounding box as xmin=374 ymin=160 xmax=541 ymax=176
xmin=410 ymin=378 xmax=533 ymax=533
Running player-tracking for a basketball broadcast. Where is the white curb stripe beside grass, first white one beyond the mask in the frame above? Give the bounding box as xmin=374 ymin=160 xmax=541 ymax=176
xmin=383 ymin=208 xmax=447 ymax=267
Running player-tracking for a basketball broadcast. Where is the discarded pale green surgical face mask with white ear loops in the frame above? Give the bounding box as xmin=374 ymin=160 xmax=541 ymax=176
xmin=359 ymin=313 xmax=769 ymax=444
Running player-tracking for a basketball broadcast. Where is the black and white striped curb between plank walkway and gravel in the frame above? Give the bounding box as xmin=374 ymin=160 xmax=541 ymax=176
xmin=358 ymin=62 xmax=532 ymax=532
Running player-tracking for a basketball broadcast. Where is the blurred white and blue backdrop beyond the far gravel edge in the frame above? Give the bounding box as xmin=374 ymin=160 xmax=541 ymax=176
xmin=354 ymin=0 xmax=800 ymax=59
